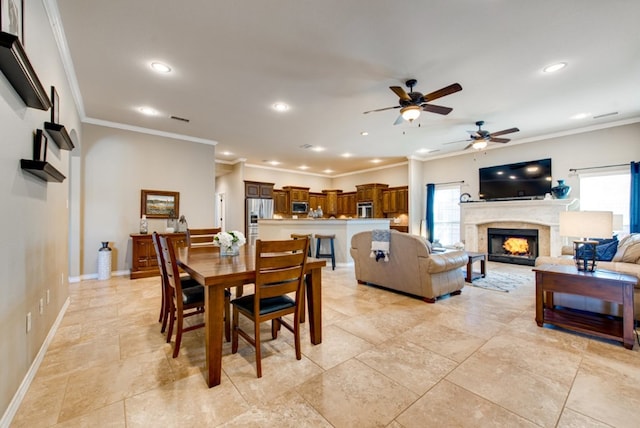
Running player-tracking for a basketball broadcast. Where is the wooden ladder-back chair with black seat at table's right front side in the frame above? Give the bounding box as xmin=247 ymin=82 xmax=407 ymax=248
xmin=231 ymin=238 xmax=309 ymax=377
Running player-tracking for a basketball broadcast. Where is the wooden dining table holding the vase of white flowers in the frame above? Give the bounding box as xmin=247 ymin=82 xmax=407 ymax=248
xmin=177 ymin=245 xmax=327 ymax=388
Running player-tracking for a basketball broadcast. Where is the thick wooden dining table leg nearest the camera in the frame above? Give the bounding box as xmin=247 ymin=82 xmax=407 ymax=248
xmin=204 ymin=286 xmax=224 ymax=388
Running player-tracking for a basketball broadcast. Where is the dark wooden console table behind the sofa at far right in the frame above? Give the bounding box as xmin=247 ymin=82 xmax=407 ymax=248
xmin=533 ymin=265 xmax=638 ymax=349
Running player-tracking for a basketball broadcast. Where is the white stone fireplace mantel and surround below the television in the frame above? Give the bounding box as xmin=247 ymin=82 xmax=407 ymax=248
xmin=460 ymin=199 xmax=578 ymax=256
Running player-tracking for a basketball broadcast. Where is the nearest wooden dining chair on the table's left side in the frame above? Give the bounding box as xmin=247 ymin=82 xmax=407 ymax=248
xmin=159 ymin=236 xmax=231 ymax=358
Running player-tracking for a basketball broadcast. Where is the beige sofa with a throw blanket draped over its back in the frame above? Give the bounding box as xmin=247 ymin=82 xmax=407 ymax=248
xmin=350 ymin=230 xmax=468 ymax=303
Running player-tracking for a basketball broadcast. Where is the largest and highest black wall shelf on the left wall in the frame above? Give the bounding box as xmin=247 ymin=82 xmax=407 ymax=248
xmin=0 ymin=31 xmax=51 ymax=111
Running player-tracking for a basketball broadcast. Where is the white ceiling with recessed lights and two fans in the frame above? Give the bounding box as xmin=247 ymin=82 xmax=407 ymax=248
xmin=57 ymin=0 xmax=640 ymax=176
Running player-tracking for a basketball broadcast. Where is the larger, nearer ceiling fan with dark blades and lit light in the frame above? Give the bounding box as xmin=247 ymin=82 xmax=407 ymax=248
xmin=364 ymin=79 xmax=462 ymax=125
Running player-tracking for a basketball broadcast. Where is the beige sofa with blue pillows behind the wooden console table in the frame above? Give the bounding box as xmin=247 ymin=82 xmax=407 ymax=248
xmin=536 ymin=233 xmax=640 ymax=320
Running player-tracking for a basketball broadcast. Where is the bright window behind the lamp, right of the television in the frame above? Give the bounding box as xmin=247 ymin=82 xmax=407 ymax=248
xmin=580 ymin=171 xmax=631 ymax=233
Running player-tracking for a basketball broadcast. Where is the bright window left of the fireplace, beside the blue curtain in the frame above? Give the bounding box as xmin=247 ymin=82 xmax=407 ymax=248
xmin=433 ymin=184 xmax=460 ymax=246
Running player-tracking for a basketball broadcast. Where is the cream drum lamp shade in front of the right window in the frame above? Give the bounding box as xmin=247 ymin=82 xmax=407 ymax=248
xmin=560 ymin=211 xmax=613 ymax=238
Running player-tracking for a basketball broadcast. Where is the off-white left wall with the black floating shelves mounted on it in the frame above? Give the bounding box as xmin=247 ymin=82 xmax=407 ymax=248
xmin=0 ymin=1 xmax=80 ymax=415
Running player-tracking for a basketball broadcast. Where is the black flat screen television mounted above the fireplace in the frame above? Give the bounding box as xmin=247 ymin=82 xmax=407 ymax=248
xmin=479 ymin=159 xmax=551 ymax=201
